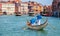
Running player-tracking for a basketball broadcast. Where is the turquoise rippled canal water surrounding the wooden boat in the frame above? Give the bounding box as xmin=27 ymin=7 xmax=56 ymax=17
xmin=0 ymin=15 xmax=60 ymax=36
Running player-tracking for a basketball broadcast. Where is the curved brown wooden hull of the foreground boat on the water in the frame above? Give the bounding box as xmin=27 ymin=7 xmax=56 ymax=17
xmin=27 ymin=19 xmax=48 ymax=30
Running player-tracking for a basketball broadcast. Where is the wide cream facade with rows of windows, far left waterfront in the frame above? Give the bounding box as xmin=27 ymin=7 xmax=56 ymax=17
xmin=2 ymin=3 xmax=15 ymax=14
